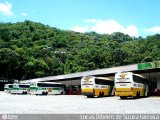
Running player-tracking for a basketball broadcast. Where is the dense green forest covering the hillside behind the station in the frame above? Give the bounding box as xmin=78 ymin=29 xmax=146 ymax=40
xmin=0 ymin=21 xmax=160 ymax=79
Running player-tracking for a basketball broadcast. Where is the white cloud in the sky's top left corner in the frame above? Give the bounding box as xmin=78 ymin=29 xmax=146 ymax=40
xmin=0 ymin=2 xmax=13 ymax=16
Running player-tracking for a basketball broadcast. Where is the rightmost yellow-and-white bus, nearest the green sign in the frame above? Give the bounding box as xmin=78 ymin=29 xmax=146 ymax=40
xmin=115 ymin=72 xmax=149 ymax=99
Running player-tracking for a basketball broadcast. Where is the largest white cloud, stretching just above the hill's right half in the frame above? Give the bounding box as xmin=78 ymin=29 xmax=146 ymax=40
xmin=71 ymin=19 xmax=138 ymax=37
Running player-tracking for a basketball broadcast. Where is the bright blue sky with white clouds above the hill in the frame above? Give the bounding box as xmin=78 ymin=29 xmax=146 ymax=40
xmin=0 ymin=0 xmax=160 ymax=37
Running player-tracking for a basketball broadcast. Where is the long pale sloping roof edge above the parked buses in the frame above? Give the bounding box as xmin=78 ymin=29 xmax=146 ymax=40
xmin=20 ymin=64 xmax=138 ymax=83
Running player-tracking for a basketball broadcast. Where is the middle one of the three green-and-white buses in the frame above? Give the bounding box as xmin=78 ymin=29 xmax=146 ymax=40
xmin=11 ymin=83 xmax=30 ymax=94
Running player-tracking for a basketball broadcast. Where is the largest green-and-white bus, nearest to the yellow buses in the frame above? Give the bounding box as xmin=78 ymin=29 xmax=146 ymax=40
xmin=30 ymin=82 xmax=66 ymax=95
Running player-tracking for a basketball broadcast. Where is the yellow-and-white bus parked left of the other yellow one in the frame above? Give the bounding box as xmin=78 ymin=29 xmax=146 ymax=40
xmin=81 ymin=76 xmax=114 ymax=98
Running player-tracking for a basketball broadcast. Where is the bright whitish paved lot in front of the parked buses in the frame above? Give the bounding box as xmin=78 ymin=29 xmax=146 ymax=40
xmin=0 ymin=92 xmax=160 ymax=114
